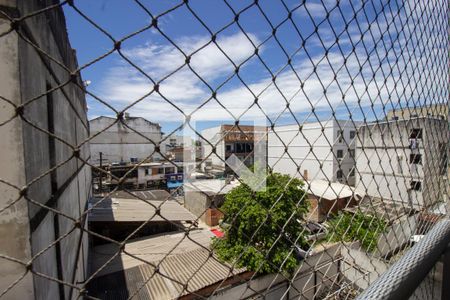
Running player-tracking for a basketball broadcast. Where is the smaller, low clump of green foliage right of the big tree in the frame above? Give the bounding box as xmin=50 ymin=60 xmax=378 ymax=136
xmin=329 ymin=211 xmax=387 ymax=251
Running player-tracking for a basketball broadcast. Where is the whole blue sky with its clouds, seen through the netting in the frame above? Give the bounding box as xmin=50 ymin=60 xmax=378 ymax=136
xmin=64 ymin=0 xmax=446 ymax=132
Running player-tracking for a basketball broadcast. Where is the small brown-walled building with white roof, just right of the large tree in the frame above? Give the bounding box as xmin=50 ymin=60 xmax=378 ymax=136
xmin=305 ymin=179 xmax=363 ymax=222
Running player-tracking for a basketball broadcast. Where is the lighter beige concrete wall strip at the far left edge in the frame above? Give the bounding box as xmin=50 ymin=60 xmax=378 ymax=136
xmin=0 ymin=8 xmax=34 ymax=299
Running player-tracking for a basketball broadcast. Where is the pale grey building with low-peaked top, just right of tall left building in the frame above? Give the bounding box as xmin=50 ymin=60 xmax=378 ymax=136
xmin=89 ymin=114 xmax=162 ymax=165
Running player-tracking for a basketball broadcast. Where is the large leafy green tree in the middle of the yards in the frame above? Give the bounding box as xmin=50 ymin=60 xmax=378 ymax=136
xmin=213 ymin=173 xmax=308 ymax=274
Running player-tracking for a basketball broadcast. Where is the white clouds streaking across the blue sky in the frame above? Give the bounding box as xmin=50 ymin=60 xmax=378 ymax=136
xmin=93 ymin=1 xmax=445 ymax=122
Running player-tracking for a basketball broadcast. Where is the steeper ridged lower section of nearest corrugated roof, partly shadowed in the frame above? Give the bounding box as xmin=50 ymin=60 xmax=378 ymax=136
xmin=89 ymin=231 xmax=245 ymax=299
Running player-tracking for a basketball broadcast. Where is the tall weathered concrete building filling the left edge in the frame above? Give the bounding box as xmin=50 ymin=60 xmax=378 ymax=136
xmin=0 ymin=0 xmax=91 ymax=299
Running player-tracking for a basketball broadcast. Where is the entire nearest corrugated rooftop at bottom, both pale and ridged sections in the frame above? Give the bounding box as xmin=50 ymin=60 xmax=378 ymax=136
xmin=89 ymin=230 xmax=245 ymax=299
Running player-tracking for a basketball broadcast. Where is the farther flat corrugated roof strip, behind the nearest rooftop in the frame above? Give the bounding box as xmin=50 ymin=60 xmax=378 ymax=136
xmin=88 ymin=198 xmax=197 ymax=222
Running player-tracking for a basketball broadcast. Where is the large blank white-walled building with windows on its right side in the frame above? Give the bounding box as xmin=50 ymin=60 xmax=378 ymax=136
xmin=267 ymin=120 xmax=358 ymax=185
